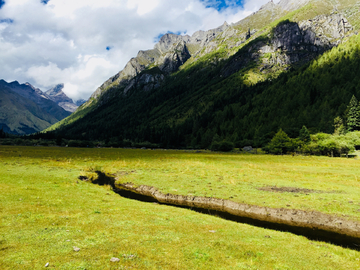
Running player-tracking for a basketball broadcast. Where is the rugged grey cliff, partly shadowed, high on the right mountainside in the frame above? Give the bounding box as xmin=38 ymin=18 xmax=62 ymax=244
xmin=222 ymin=14 xmax=353 ymax=76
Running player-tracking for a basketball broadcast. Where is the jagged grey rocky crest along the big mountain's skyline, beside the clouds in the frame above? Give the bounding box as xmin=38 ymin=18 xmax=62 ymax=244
xmin=91 ymin=22 xmax=231 ymax=99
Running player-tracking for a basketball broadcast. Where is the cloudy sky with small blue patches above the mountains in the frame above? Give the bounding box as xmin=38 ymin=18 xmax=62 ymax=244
xmin=0 ymin=0 xmax=278 ymax=101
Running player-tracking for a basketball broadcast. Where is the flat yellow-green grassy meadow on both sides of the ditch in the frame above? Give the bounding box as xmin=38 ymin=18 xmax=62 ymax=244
xmin=0 ymin=146 xmax=360 ymax=269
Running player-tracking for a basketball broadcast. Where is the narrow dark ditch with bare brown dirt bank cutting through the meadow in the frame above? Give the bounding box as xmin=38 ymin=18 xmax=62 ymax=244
xmin=80 ymin=172 xmax=360 ymax=250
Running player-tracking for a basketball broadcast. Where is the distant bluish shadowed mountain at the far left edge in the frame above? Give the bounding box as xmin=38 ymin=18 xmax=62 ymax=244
xmin=0 ymin=80 xmax=70 ymax=135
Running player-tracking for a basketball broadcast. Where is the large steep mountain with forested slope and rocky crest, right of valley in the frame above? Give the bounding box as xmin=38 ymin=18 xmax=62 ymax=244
xmin=20 ymin=0 xmax=360 ymax=148
